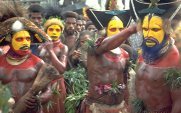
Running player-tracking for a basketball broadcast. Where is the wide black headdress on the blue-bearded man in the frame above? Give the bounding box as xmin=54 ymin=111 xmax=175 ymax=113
xmin=130 ymin=0 xmax=181 ymax=21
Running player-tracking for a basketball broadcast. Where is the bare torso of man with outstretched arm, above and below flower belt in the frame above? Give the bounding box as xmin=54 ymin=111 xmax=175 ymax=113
xmin=87 ymin=49 xmax=129 ymax=105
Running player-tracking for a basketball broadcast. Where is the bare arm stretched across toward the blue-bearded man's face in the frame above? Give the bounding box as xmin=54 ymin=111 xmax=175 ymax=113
xmin=95 ymin=25 xmax=137 ymax=54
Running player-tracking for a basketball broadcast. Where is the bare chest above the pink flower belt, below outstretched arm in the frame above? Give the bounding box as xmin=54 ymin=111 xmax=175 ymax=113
xmin=88 ymin=55 xmax=126 ymax=84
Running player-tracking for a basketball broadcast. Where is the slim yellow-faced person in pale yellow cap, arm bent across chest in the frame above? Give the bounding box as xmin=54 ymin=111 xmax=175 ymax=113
xmin=39 ymin=18 xmax=68 ymax=113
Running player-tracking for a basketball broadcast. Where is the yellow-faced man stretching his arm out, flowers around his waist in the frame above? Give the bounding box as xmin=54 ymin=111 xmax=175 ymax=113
xmin=81 ymin=13 xmax=136 ymax=113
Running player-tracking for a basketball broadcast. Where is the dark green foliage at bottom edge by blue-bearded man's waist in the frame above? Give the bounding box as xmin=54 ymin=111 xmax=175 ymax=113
xmin=131 ymin=98 xmax=145 ymax=113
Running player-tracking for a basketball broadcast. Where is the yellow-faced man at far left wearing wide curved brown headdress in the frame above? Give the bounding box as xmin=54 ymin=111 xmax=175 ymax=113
xmin=0 ymin=13 xmax=54 ymax=113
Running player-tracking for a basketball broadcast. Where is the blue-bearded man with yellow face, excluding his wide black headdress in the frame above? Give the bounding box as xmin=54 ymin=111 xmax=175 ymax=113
xmin=130 ymin=0 xmax=181 ymax=113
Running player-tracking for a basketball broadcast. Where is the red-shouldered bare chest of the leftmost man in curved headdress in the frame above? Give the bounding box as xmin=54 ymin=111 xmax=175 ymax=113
xmin=0 ymin=54 xmax=43 ymax=101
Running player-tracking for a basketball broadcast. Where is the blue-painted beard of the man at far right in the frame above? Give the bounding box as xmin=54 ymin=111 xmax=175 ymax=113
xmin=142 ymin=36 xmax=168 ymax=63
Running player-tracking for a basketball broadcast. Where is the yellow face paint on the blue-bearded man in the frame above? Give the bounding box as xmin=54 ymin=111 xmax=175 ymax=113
xmin=142 ymin=16 xmax=165 ymax=47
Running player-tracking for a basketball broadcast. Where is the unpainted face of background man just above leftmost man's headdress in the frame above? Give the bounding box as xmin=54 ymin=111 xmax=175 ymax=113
xmin=30 ymin=13 xmax=43 ymax=27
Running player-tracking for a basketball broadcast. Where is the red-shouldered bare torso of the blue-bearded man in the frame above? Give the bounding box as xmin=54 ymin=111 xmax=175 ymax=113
xmin=135 ymin=46 xmax=179 ymax=111
